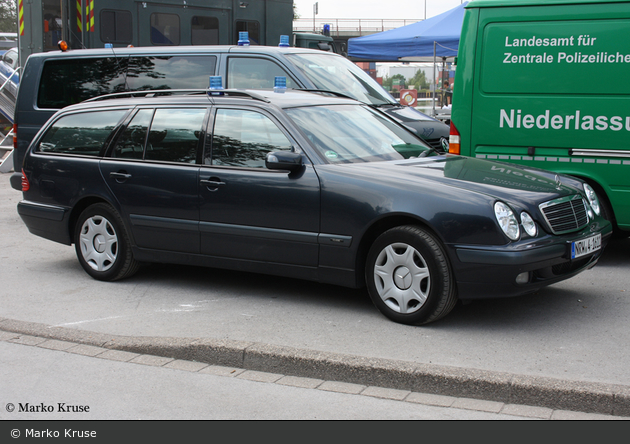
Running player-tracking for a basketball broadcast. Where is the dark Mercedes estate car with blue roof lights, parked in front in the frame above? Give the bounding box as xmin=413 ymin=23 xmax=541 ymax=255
xmin=17 ymin=89 xmax=611 ymax=324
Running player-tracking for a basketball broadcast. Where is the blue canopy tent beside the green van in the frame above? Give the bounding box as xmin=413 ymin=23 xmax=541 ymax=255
xmin=348 ymin=2 xmax=468 ymax=62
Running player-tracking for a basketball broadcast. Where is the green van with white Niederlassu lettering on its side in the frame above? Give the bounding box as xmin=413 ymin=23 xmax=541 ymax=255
xmin=449 ymin=0 xmax=630 ymax=236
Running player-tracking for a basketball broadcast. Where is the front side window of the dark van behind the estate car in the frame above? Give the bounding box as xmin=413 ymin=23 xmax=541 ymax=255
xmin=226 ymin=57 xmax=297 ymax=89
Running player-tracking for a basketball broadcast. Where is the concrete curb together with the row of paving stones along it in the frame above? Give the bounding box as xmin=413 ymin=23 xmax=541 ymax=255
xmin=0 ymin=318 xmax=630 ymax=420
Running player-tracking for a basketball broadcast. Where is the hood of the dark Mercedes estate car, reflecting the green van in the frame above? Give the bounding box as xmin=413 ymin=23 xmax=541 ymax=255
xmin=328 ymin=155 xmax=578 ymax=205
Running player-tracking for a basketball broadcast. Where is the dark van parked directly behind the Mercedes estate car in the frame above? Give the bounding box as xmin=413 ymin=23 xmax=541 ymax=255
xmin=11 ymin=46 xmax=449 ymax=190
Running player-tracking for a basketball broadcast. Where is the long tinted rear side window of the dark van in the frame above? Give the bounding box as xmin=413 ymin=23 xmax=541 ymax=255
xmin=37 ymin=56 xmax=216 ymax=109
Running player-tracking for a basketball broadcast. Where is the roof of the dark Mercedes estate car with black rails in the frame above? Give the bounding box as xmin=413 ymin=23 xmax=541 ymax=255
xmin=60 ymin=89 xmax=362 ymax=113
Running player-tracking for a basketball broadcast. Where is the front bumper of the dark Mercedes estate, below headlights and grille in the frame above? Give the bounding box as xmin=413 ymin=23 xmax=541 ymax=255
xmin=451 ymin=223 xmax=612 ymax=299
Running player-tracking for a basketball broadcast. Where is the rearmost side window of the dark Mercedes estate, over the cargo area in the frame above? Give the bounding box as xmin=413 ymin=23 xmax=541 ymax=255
xmin=36 ymin=110 xmax=127 ymax=156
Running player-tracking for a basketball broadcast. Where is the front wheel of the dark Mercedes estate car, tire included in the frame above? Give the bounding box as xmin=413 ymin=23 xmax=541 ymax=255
xmin=365 ymin=225 xmax=457 ymax=325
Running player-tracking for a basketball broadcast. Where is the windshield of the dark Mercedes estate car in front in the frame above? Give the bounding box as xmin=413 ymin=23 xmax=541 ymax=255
xmin=285 ymin=105 xmax=431 ymax=163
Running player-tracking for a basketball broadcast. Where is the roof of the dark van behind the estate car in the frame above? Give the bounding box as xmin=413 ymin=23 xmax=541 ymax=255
xmin=23 ymin=45 xmax=341 ymax=59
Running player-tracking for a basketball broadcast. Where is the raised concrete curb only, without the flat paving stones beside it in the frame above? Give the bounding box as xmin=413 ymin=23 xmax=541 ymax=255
xmin=0 ymin=318 xmax=630 ymax=417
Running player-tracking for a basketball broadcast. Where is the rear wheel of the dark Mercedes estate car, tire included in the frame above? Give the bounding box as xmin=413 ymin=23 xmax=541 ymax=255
xmin=74 ymin=203 xmax=140 ymax=281
